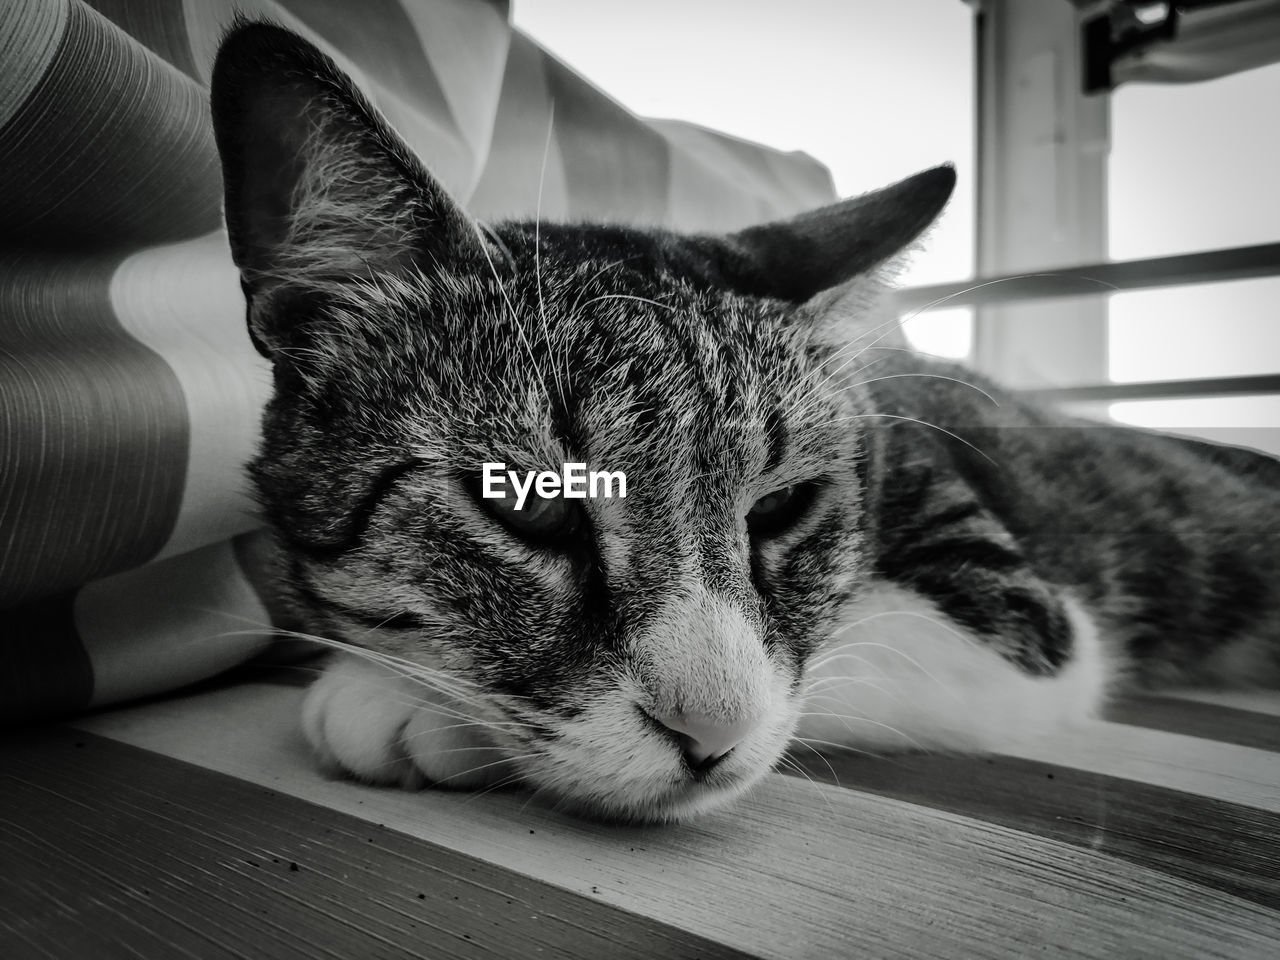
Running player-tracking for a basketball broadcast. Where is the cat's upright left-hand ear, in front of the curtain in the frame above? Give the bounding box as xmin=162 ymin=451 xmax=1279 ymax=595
xmin=210 ymin=22 xmax=483 ymax=356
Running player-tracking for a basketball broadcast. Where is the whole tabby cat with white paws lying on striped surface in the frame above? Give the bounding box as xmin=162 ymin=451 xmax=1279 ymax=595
xmin=211 ymin=22 xmax=1280 ymax=820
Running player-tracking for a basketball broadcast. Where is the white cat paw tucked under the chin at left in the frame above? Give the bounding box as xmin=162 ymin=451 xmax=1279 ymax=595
xmin=302 ymin=655 xmax=515 ymax=790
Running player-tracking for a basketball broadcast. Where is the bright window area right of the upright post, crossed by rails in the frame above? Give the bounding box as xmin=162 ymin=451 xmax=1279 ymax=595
xmin=1107 ymin=64 xmax=1280 ymax=453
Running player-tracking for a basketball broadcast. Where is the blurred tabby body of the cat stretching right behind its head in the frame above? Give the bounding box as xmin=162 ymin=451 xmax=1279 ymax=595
xmin=872 ymin=353 xmax=1280 ymax=687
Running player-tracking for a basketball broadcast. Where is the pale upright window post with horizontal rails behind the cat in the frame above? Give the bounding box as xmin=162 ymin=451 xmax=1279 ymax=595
xmin=897 ymin=0 xmax=1280 ymax=403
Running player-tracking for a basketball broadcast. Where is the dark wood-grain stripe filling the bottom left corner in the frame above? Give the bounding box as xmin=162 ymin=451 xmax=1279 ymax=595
xmin=0 ymin=730 xmax=744 ymax=960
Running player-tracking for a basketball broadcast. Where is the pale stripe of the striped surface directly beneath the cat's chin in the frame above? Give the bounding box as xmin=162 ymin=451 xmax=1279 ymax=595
xmin=70 ymin=685 xmax=1280 ymax=960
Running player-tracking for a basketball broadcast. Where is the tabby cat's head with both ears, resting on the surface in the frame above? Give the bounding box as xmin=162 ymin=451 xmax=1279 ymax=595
xmin=212 ymin=18 xmax=954 ymax=819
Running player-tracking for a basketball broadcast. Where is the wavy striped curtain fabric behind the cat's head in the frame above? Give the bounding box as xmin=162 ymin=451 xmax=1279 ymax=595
xmin=0 ymin=0 xmax=833 ymax=722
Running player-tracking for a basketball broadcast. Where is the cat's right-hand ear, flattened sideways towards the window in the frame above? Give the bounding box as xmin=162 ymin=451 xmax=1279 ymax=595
xmin=719 ymin=165 xmax=956 ymax=343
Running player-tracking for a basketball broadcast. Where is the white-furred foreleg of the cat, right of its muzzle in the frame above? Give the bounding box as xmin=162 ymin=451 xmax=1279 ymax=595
xmin=799 ymin=582 xmax=1111 ymax=753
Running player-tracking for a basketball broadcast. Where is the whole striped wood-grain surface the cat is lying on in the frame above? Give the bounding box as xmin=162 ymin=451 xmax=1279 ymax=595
xmin=0 ymin=682 xmax=1280 ymax=960
